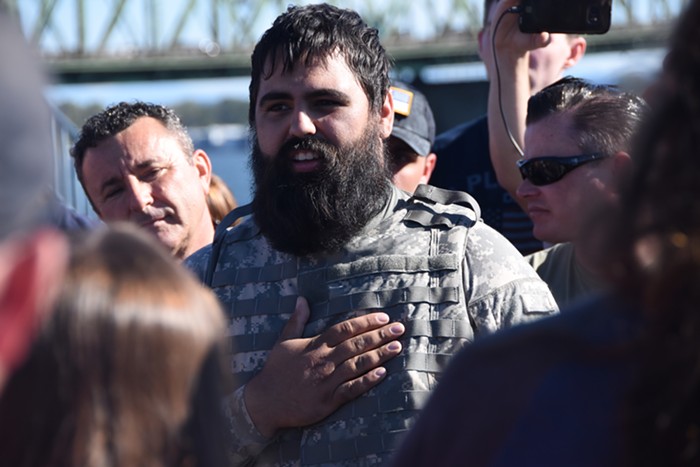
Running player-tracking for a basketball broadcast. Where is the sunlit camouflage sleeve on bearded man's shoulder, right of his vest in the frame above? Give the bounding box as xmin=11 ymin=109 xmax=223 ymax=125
xmin=464 ymin=222 xmax=558 ymax=335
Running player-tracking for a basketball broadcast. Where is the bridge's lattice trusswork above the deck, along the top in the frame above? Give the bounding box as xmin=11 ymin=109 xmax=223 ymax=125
xmin=17 ymin=0 xmax=688 ymax=60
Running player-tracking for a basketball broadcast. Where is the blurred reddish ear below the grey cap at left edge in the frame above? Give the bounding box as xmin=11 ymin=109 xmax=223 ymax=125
xmin=0 ymin=229 xmax=68 ymax=387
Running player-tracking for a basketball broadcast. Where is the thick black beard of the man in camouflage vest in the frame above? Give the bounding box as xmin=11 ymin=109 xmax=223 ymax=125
xmin=251 ymin=129 xmax=391 ymax=256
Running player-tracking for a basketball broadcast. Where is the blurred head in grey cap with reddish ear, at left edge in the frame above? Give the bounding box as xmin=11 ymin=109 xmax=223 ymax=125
xmin=0 ymin=10 xmax=66 ymax=391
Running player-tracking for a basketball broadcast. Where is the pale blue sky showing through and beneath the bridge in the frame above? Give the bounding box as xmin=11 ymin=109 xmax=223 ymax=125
xmin=37 ymin=0 xmax=681 ymax=105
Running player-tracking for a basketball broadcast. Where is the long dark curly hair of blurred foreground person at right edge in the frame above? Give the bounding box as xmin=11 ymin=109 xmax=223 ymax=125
xmin=596 ymin=0 xmax=700 ymax=466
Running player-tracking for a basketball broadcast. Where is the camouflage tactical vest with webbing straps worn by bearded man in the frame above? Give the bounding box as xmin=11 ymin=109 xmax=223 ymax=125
xmin=208 ymin=186 xmax=479 ymax=465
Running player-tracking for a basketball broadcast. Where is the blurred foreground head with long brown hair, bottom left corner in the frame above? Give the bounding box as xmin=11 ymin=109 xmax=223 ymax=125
xmin=0 ymin=224 xmax=230 ymax=467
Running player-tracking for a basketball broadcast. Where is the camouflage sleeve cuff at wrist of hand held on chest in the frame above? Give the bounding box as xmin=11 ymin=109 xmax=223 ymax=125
xmin=224 ymin=385 xmax=274 ymax=465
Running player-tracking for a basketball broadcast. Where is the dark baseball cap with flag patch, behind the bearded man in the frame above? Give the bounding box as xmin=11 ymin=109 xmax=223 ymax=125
xmin=391 ymin=82 xmax=435 ymax=156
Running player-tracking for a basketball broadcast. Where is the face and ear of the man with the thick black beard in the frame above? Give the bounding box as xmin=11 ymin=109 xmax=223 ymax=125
xmin=255 ymin=51 xmax=393 ymax=173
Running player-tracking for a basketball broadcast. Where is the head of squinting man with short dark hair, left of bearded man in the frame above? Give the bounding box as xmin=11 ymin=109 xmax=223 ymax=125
xmin=71 ymin=102 xmax=214 ymax=259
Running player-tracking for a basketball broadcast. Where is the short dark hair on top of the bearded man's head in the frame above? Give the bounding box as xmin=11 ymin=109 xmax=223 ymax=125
xmin=248 ymin=3 xmax=391 ymax=127
